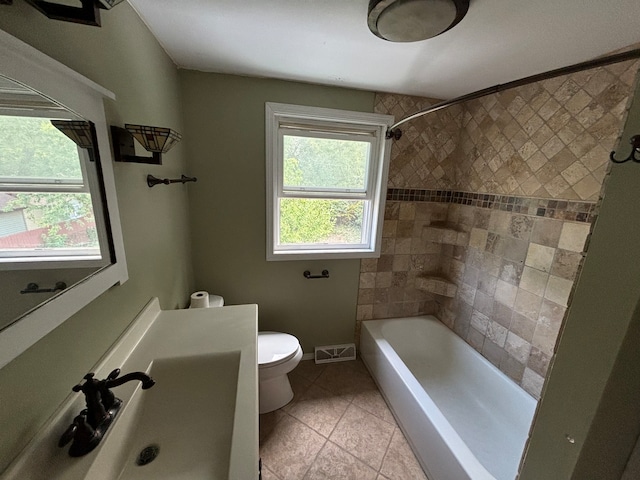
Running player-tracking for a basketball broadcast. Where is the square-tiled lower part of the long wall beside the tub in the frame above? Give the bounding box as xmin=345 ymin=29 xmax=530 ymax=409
xmin=438 ymin=197 xmax=591 ymax=397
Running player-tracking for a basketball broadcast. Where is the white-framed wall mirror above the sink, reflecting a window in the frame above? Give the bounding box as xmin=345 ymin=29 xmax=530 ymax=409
xmin=0 ymin=31 xmax=127 ymax=367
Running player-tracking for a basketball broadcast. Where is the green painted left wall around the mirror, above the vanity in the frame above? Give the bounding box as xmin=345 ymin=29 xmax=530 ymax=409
xmin=0 ymin=1 xmax=193 ymax=471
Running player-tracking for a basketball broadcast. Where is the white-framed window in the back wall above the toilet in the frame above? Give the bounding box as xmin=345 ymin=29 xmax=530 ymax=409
xmin=266 ymin=103 xmax=393 ymax=260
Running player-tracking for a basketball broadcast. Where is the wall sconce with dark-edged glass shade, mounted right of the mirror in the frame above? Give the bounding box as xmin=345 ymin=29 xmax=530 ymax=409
xmin=111 ymin=123 xmax=182 ymax=165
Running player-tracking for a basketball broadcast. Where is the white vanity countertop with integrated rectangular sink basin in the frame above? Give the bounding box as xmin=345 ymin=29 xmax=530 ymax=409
xmin=1 ymin=301 xmax=258 ymax=480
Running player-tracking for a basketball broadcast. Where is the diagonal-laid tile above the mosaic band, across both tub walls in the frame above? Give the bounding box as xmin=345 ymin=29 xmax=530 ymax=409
xmin=375 ymin=60 xmax=640 ymax=197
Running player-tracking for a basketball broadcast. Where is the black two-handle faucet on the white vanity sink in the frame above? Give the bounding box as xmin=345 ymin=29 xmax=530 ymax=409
xmin=58 ymin=368 xmax=155 ymax=457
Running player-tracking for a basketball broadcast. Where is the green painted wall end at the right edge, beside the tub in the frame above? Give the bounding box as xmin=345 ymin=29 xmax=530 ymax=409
xmin=520 ymin=73 xmax=640 ymax=480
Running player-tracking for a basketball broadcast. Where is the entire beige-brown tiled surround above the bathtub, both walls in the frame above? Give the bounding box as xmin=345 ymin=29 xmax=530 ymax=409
xmin=357 ymin=55 xmax=638 ymax=397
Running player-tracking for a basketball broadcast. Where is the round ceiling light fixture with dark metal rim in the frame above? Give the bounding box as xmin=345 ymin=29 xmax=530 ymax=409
xmin=367 ymin=0 xmax=469 ymax=42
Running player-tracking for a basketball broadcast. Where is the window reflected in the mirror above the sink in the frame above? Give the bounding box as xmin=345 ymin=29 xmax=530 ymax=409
xmin=0 ymin=112 xmax=103 ymax=269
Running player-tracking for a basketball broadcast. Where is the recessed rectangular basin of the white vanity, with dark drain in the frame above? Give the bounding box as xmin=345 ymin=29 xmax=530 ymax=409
xmin=87 ymin=351 xmax=240 ymax=480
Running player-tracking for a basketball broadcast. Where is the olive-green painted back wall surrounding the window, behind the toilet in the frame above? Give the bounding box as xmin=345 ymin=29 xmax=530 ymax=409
xmin=180 ymin=70 xmax=374 ymax=353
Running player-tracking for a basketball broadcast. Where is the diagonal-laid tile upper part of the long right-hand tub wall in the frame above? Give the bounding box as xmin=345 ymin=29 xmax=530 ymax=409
xmin=458 ymin=60 xmax=639 ymax=202
